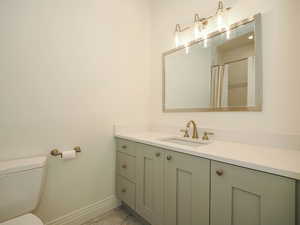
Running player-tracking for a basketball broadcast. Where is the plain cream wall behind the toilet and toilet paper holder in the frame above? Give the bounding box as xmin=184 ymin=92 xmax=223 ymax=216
xmin=0 ymin=0 xmax=150 ymax=222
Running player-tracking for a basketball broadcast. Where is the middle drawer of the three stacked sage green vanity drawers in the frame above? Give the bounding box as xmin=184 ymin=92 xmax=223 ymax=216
xmin=117 ymin=152 xmax=136 ymax=182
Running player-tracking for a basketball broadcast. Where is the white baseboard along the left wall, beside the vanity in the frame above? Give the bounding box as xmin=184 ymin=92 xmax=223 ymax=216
xmin=46 ymin=196 xmax=120 ymax=225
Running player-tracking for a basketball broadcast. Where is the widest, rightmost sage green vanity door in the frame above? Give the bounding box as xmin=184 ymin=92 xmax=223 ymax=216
xmin=211 ymin=162 xmax=295 ymax=225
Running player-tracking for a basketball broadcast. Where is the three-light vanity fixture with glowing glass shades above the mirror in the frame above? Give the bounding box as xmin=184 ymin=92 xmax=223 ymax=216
xmin=175 ymin=0 xmax=231 ymax=47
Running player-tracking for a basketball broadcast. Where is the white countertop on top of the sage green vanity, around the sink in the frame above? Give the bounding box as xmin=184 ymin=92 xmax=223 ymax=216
xmin=115 ymin=132 xmax=300 ymax=180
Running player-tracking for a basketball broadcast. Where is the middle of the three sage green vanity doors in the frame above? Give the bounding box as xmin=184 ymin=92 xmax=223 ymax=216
xmin=164 ymin=151 xmax=210 ymax=225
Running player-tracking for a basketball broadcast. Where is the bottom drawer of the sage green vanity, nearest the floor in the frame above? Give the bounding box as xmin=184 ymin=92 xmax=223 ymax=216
xmin=117 ymin=176 xmax=135 ymax=209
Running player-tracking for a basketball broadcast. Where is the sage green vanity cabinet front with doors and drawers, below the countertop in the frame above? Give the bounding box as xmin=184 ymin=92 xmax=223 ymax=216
xmin=116 ymin=139 xmax=300 ymax=225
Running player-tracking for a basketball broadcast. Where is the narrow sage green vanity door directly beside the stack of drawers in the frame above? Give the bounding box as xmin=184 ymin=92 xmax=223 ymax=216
xmin=136 ymin=144 xmax=164 ymax=225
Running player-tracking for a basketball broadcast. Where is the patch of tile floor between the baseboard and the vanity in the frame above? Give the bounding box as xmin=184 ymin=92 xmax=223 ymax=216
xmin=82 ymin=208 xmax=144 ymax=225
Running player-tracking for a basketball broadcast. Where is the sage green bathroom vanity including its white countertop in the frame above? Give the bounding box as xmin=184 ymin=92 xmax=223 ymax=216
xmin=116 ymin=134 xmax=300 ymax=225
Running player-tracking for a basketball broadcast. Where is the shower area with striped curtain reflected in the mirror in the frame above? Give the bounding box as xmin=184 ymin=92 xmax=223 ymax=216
xmin=211 ymin=32 xmax=255 ymax=107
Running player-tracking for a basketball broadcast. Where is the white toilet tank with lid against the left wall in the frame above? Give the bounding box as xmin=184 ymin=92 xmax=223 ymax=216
xmin=0 ymin=157 xmax=46 ymax=222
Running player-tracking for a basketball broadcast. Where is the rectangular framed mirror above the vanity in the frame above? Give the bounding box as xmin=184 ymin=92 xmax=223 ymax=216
xmin=163 ymin=15 xmax=262 ymax=112
